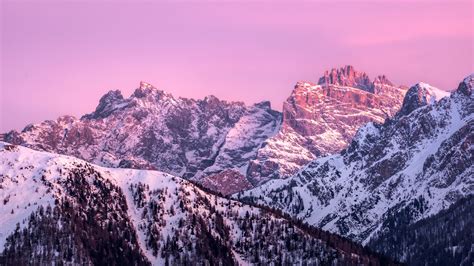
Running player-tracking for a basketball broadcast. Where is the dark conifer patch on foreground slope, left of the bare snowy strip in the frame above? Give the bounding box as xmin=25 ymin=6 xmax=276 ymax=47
xmin=0 ymin=164 xmax=149 ymax=265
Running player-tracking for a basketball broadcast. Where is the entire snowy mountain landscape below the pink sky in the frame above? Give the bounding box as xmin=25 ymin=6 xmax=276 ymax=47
xmin=0 ymin=66 xmax=474 ymax=265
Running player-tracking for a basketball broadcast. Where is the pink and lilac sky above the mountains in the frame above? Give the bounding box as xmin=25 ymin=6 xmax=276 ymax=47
xmin=0 ymin=0 xmax=474 ymax=132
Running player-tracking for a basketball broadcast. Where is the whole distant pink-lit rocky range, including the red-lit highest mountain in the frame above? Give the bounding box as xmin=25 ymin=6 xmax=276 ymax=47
xmin=0 ymin=66 xmax=406 ymax=195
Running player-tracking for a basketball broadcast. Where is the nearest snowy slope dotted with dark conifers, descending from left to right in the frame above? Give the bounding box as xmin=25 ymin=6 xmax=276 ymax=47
xmin=0 ymin=142 xmax=390 ymax=265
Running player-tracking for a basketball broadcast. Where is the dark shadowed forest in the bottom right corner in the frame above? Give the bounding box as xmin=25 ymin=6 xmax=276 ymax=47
xmin=369 ymin=196 xmax=474 ymax=266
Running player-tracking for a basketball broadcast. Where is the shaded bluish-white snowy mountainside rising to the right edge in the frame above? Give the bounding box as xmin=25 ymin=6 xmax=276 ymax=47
xmin=236 ymin=75 xmax=474 ymax=259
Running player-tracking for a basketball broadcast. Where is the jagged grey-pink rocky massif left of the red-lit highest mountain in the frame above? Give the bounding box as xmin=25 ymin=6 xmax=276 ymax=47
xmin=3 ymin=82 xmax=281 ymax=193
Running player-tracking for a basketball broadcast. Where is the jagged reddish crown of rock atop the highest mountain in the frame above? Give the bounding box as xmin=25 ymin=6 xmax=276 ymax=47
xmin=318 ymin=65 xmax=373 ymax=92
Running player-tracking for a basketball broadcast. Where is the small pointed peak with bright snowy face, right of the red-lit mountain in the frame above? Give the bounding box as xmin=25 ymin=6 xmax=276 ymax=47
xmin=397 ymin=82 xmax=449 ymax=116
